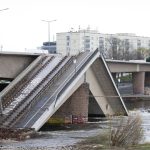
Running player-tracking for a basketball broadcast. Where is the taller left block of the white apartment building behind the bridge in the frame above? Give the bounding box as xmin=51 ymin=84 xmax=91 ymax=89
xmin=56 ymin=30 xmax=99 ymax=55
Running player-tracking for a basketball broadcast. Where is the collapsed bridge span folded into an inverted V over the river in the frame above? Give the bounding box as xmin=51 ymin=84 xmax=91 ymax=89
xmin=0 ymin=50 xmax=128 ymax=130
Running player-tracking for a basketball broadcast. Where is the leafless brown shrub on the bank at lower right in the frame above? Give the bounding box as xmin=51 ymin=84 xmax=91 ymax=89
xmin=111 ymin=116 xmax=143 ymax=147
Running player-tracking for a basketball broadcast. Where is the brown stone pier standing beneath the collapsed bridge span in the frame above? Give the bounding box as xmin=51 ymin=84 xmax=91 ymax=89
xmin=48 ymin=83 xmax=89 ymax=123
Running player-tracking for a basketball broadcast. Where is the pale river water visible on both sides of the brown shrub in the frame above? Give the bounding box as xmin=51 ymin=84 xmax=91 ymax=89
xmin=0 ymin=110 xmax=150 ymax=150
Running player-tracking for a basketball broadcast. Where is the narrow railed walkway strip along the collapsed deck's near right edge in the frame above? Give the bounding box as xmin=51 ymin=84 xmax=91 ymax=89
xmin=21 ymin=50 xmax=98 ymax=127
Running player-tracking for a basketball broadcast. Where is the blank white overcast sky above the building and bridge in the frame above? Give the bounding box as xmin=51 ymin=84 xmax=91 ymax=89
xmin=0 ymin=0 xmax=150 ymax=51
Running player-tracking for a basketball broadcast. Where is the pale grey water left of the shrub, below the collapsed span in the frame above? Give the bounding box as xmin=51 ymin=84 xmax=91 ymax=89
xmin=0 ymin=129 xmax=102 ymax=150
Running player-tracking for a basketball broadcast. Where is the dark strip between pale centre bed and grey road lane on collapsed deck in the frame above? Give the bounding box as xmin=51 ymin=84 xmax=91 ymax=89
xmin=0 ymin=57 xmax=72 ymax=126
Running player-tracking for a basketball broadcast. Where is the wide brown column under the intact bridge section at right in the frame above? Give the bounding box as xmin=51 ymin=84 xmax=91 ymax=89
xmin=132 ymin=72 xmax=145 ymax=94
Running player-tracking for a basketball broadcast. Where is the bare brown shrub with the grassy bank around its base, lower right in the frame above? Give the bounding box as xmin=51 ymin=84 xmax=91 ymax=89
xmin=79 ymin=116 xmax=144 ymax=150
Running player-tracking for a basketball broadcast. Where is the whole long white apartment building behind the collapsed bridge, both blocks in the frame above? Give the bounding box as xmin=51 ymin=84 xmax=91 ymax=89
xmin=56 ymin=29 xmax=150 ymax=58
